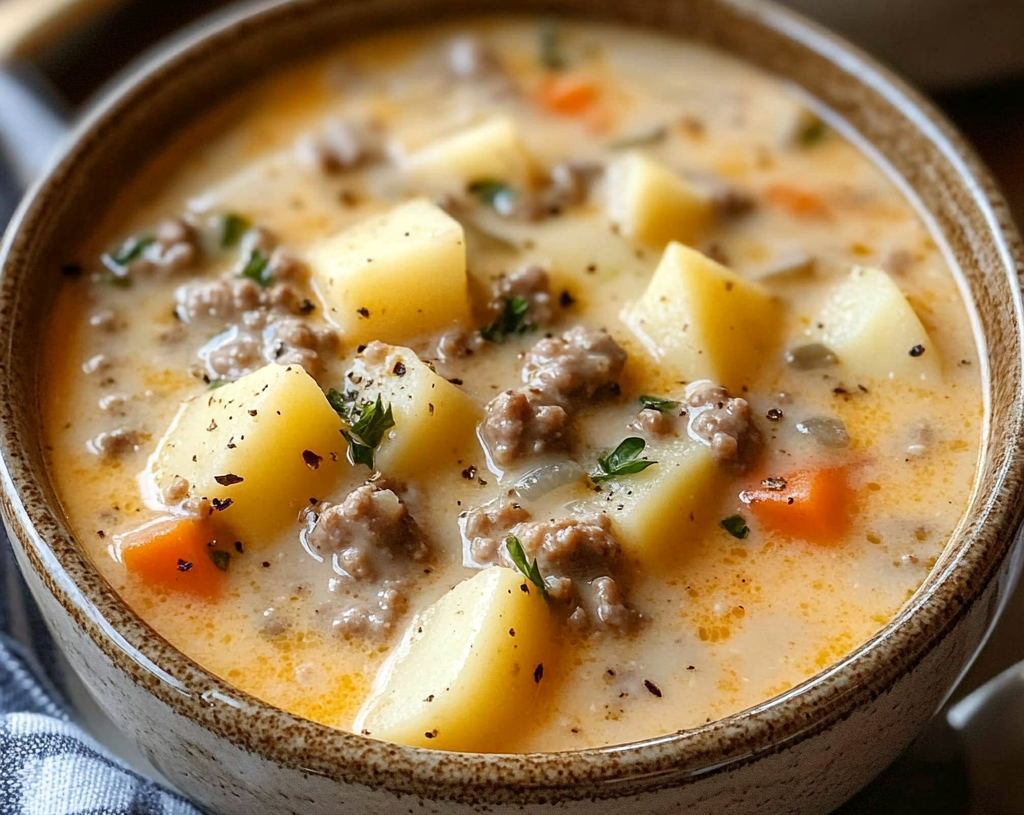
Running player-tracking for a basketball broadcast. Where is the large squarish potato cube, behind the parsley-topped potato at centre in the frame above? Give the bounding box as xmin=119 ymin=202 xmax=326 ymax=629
xmin=308 ymin=199 xmax=469 ymax=342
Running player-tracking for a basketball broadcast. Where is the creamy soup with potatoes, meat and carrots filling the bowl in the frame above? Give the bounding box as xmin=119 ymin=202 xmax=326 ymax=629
xmin=43 ymin=19 xmax=983 ymax=752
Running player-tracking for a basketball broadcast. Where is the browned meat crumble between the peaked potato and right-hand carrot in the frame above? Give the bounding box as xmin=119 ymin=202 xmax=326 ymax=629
xmin=686 ymin=379 xmax=762 ymax=472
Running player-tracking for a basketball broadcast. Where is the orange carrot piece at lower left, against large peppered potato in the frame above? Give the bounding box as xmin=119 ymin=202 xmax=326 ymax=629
xmin=119 ymin=518 xmax=224 ymax=600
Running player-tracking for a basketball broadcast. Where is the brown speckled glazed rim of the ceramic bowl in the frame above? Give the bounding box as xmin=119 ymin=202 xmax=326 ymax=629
xmin=0 ymin=0 xmax=1024 ymax=806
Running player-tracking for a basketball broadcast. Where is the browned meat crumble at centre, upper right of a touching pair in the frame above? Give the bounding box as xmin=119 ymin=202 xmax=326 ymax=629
xmin=522 ymin=326 xmax=626 ymax=406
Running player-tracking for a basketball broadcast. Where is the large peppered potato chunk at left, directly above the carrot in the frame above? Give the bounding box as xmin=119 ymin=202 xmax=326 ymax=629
xmin=142 ymin=364 xmax=347 ymax=545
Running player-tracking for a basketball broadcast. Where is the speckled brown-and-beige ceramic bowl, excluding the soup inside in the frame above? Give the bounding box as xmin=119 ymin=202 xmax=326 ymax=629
xmin=0 ymin=0 xmax=1024 ymax=815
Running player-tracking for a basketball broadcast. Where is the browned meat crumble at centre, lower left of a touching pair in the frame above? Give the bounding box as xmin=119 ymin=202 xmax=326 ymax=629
xmin=480 ymin=390 xmax=569 ymax=467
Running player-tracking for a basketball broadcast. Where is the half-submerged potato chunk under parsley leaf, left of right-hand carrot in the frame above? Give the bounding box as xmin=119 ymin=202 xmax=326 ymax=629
xmin=593 ymin=438 xmax=722 ymax=570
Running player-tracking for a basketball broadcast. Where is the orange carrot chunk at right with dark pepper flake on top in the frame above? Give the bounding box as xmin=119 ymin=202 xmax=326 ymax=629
xmin=739 ymin=467 xmax=853 ymax=546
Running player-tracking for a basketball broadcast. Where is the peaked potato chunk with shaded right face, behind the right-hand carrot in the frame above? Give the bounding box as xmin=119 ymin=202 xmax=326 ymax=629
xmin=623 ymin=243 xmax=779 ymax=391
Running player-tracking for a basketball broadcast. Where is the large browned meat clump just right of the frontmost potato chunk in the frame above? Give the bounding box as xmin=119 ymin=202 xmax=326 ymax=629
xmin=498 ymin=513 xmax=637 ymax=630
